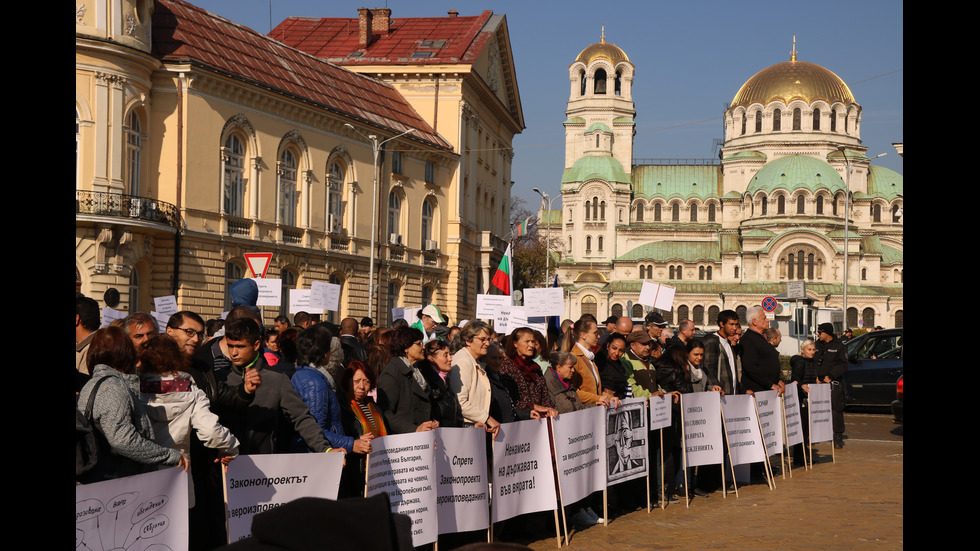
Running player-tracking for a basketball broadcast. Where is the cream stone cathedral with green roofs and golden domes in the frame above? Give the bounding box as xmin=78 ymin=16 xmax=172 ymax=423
xmin=558 ymin=37 xmax=904 ymax=328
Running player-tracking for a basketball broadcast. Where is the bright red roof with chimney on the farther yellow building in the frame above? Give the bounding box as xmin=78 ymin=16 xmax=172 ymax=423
xmin=269 ymin=11 xmax=493 ymax=65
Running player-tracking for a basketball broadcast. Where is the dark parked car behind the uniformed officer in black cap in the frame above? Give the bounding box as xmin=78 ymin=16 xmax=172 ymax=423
xmin=844 ymin=329 xmax=905 ymax=406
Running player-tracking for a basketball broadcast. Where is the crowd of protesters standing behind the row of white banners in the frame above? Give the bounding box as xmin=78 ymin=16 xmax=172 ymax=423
xmin=75 ymin=280 xmax=846 ymax=549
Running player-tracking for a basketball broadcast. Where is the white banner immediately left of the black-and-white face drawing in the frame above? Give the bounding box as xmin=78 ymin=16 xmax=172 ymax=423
xmin=551 ymin=407 xmax=606 ymax=506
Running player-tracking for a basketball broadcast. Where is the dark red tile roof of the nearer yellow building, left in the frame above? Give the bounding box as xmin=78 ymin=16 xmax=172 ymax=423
xmin=153 ymin=0 xmax=452 ymax=149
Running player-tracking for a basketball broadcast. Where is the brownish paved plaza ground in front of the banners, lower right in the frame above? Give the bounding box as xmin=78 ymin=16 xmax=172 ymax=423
xmin=521 ymin=413 xmax=904 ymax=551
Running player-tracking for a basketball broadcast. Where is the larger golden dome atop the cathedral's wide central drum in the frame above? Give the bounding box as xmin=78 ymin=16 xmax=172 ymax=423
xmin=731 ymin=59 xmax=857 ymax=107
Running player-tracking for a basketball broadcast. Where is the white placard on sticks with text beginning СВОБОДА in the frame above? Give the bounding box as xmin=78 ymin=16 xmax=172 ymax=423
xmin=681 ymin=392 xmax=724 ymax=467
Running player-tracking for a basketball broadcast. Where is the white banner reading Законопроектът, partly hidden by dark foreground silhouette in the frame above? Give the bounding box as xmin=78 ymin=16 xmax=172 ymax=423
xmin=224 ymin=453 xmax=344 ymax=543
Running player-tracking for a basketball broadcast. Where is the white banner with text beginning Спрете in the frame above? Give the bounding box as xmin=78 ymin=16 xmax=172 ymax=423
xmin=434 ymin=427 xmax=490 ymax=534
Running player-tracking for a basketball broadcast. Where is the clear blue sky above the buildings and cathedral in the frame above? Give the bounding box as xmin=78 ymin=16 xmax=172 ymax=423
xmin=191 ymin=0 xmax=905 ymax=210
